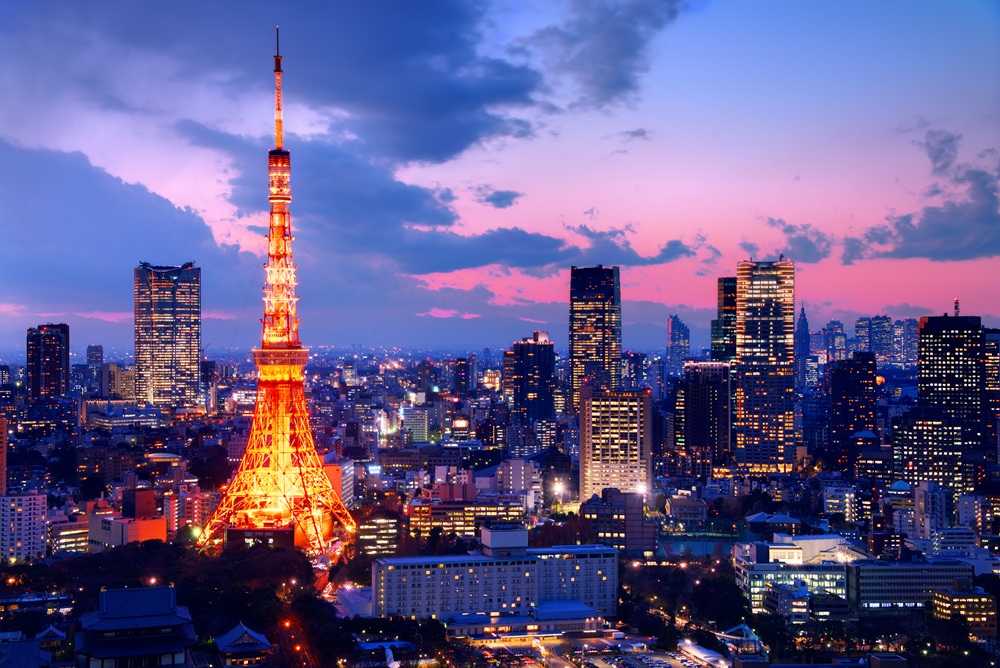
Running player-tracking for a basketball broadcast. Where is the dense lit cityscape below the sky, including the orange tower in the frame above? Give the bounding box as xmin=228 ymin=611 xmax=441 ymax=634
xmin=0 ymin=1 xmax=1000 ymax=668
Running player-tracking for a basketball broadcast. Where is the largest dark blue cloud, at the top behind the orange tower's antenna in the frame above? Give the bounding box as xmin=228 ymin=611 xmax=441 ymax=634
xmin=0 ymin=0 xmax=541 ymax=162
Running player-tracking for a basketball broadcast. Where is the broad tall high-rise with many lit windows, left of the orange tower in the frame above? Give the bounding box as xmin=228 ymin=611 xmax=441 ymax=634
xmin=134 ymin=262 xmax=201 ymax=406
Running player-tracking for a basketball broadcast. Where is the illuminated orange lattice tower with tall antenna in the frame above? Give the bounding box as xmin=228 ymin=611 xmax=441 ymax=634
xmin=198 ymin=30 xmax=356 ymax=554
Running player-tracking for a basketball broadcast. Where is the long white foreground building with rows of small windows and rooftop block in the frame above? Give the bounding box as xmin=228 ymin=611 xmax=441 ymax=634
xmin=372 ymin=525 xmax=618 ymax=619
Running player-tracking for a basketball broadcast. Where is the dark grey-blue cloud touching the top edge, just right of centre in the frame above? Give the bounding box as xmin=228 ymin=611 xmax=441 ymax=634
xmin=527 ymin=0 xmax=681 ymax=107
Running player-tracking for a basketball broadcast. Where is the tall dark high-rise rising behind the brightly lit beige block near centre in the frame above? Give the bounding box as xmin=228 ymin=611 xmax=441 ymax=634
xmin=569 ymin=265 xmax=622 ymax=412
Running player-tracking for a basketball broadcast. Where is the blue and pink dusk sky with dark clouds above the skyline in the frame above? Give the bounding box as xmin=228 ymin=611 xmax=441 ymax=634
xmin=0 ymin=0 xmax=1000 ymax=357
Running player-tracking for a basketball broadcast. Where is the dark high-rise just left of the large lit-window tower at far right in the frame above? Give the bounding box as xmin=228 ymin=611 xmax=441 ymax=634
xmin=830 ymin=352 xmax=875 ymax=477
